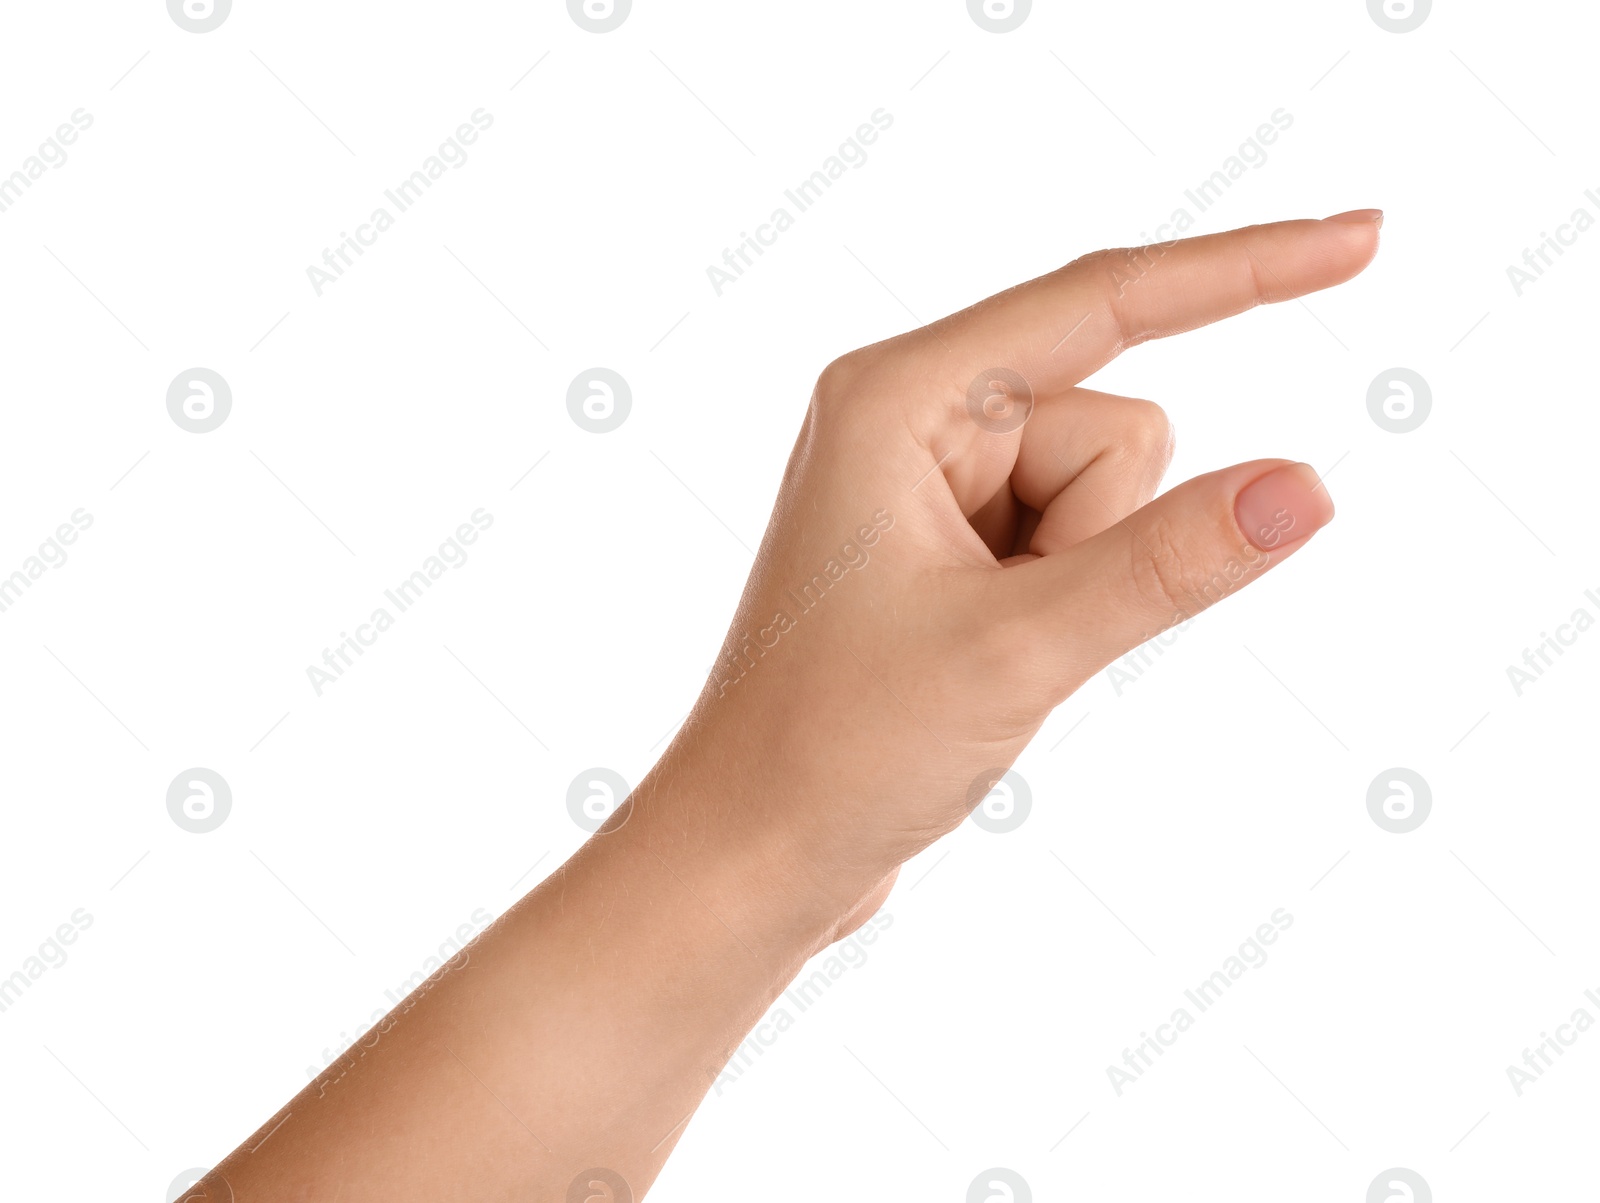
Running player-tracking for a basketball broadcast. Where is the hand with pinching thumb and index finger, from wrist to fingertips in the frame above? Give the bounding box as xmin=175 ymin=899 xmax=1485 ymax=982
xmin=667 ymin=210 xmax=1381 ymax=933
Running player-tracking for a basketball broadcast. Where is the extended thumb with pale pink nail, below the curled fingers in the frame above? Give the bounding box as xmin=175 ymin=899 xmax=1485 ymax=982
xmin=1006 ymin=459 xmax=1333 ymax=693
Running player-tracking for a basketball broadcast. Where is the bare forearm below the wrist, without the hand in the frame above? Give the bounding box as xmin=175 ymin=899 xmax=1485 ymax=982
xmin=203 ymin=753 xmax=874 ymax=1203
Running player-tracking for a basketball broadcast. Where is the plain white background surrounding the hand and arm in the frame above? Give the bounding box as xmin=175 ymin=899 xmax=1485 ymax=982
xmin=0 ymin=0 xmax=1600 ymax=1203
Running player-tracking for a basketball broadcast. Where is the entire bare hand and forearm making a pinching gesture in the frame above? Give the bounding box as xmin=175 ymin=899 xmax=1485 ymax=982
xmin=186 ymin=210 xmax=1381 ymax=1203
